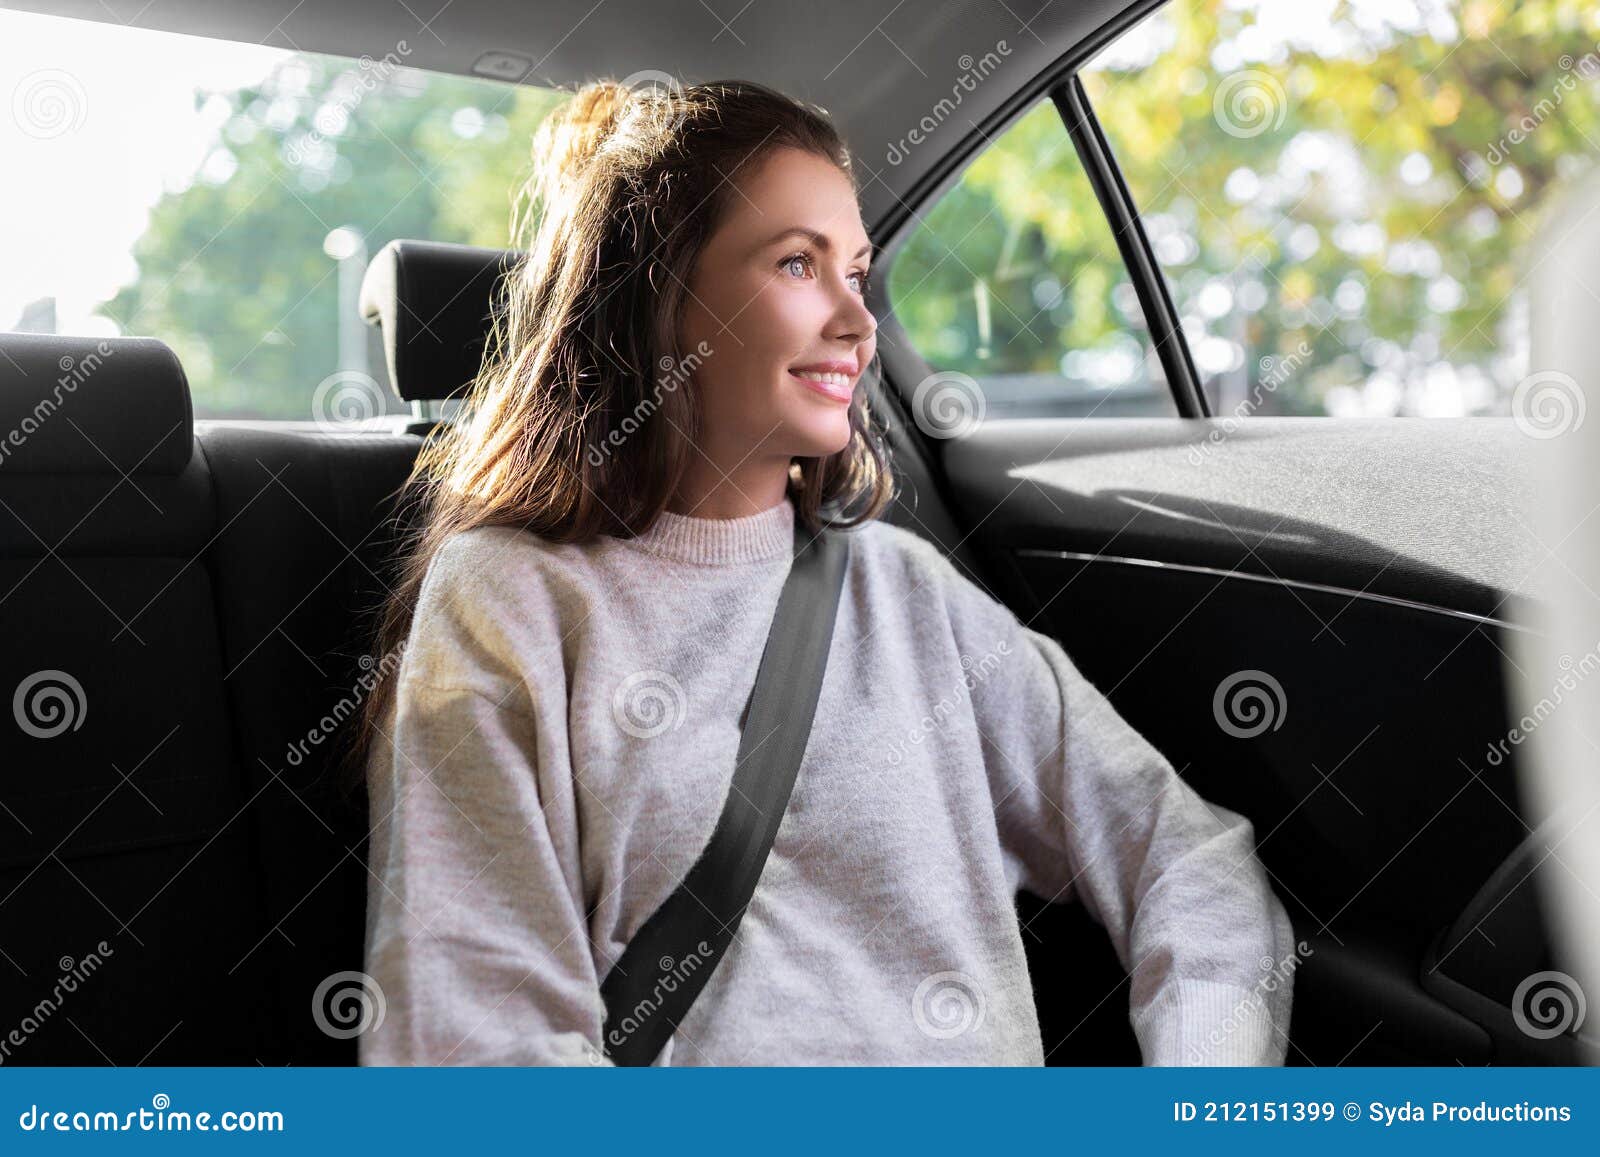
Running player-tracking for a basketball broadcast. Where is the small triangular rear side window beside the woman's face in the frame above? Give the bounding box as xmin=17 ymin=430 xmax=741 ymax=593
xmin=888 ymin=99 xmax=1178 ymax=430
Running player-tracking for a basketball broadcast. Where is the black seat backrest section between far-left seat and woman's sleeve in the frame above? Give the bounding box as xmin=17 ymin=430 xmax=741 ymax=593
xmin=198 ymin=424 xmax=421 ymax=1064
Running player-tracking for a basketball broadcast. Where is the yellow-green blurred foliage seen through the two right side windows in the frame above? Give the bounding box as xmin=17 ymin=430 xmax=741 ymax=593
xmin=891 ymin=0 xmax=1600 ymax=414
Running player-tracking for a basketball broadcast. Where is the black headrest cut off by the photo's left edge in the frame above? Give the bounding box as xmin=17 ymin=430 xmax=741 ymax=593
xmin=0 ymin=333 xmax=195 ymax=477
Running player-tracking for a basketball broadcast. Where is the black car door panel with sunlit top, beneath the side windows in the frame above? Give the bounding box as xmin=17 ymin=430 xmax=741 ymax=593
xmin=931 ymin=419 xmax=1562 ymax=1064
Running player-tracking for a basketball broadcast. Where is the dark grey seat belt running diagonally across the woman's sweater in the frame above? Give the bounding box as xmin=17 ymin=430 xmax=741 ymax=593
xmin=600 ymin=515 xmax=850 ymax=1066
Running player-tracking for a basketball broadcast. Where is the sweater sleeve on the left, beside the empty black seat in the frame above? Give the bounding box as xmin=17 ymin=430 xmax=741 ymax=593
xmin=358 ymin=537 xmax=606 ymax=1066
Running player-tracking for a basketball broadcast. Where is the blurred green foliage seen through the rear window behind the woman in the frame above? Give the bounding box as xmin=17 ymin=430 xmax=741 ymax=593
xmin=106 ymin=54 xmax=558 ymax=419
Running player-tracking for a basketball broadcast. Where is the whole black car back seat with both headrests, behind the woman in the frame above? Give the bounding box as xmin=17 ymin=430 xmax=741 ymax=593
xmin=0 ymin=242 xmax=973 ymax=1066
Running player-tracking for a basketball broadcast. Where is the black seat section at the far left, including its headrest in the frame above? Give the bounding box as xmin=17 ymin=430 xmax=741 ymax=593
xmin=0 ymin=334 xmax=264 ymax=1066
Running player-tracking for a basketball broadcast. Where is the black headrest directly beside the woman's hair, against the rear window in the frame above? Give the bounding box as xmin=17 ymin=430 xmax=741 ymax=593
xmin=360 ymin=242 xmax=523 ymax=402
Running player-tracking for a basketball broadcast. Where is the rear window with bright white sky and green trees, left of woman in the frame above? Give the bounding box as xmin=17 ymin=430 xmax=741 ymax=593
xmin=0 ymin=11 xmax=565 ymax=421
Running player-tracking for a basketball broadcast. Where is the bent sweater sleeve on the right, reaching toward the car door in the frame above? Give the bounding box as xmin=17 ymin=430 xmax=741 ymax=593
xmin=939 ymin=547 xmax=1298 ymax=1066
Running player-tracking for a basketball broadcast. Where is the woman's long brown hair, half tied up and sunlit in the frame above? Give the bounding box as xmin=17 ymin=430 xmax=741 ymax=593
xmin=332 ymin=80 xmax=894 ymax=792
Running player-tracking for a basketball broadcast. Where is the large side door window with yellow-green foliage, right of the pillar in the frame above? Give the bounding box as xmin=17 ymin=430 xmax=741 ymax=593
xmin=1082 ymin=0 xmax=1600 ymax=416
